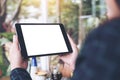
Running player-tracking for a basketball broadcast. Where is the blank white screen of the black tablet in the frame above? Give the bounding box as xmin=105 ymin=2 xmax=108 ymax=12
xmin=21 ymin=25 xmax=68 ymax=56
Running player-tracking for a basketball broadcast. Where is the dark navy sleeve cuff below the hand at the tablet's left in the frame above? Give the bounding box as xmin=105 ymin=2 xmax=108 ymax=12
xmin=10 ymin=68 xmax=32 ymax=80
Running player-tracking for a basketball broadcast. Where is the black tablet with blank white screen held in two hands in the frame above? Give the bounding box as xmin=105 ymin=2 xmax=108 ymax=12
xmin=15 ymin=23 xmax=72 ymax=58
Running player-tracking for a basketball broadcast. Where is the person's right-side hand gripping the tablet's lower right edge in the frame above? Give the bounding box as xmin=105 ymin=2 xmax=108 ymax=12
xmin=60 ymin=35 xmax=78 ymax=77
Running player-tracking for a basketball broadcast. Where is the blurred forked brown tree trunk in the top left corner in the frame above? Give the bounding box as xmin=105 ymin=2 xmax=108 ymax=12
xmin=0 ymin=0 xmax=22 ymax=32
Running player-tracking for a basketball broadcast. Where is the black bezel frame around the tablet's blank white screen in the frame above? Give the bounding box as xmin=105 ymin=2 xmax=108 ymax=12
xmin=15 ymin=23 xmax=73 ymax=58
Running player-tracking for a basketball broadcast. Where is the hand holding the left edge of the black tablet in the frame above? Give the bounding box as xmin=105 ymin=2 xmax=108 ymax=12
xmin=9 ymin=35 xmax=28 ymax=70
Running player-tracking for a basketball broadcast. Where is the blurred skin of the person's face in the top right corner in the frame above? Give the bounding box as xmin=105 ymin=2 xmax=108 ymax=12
xmin=106 ymin=0 xmax=120 ymax=19
